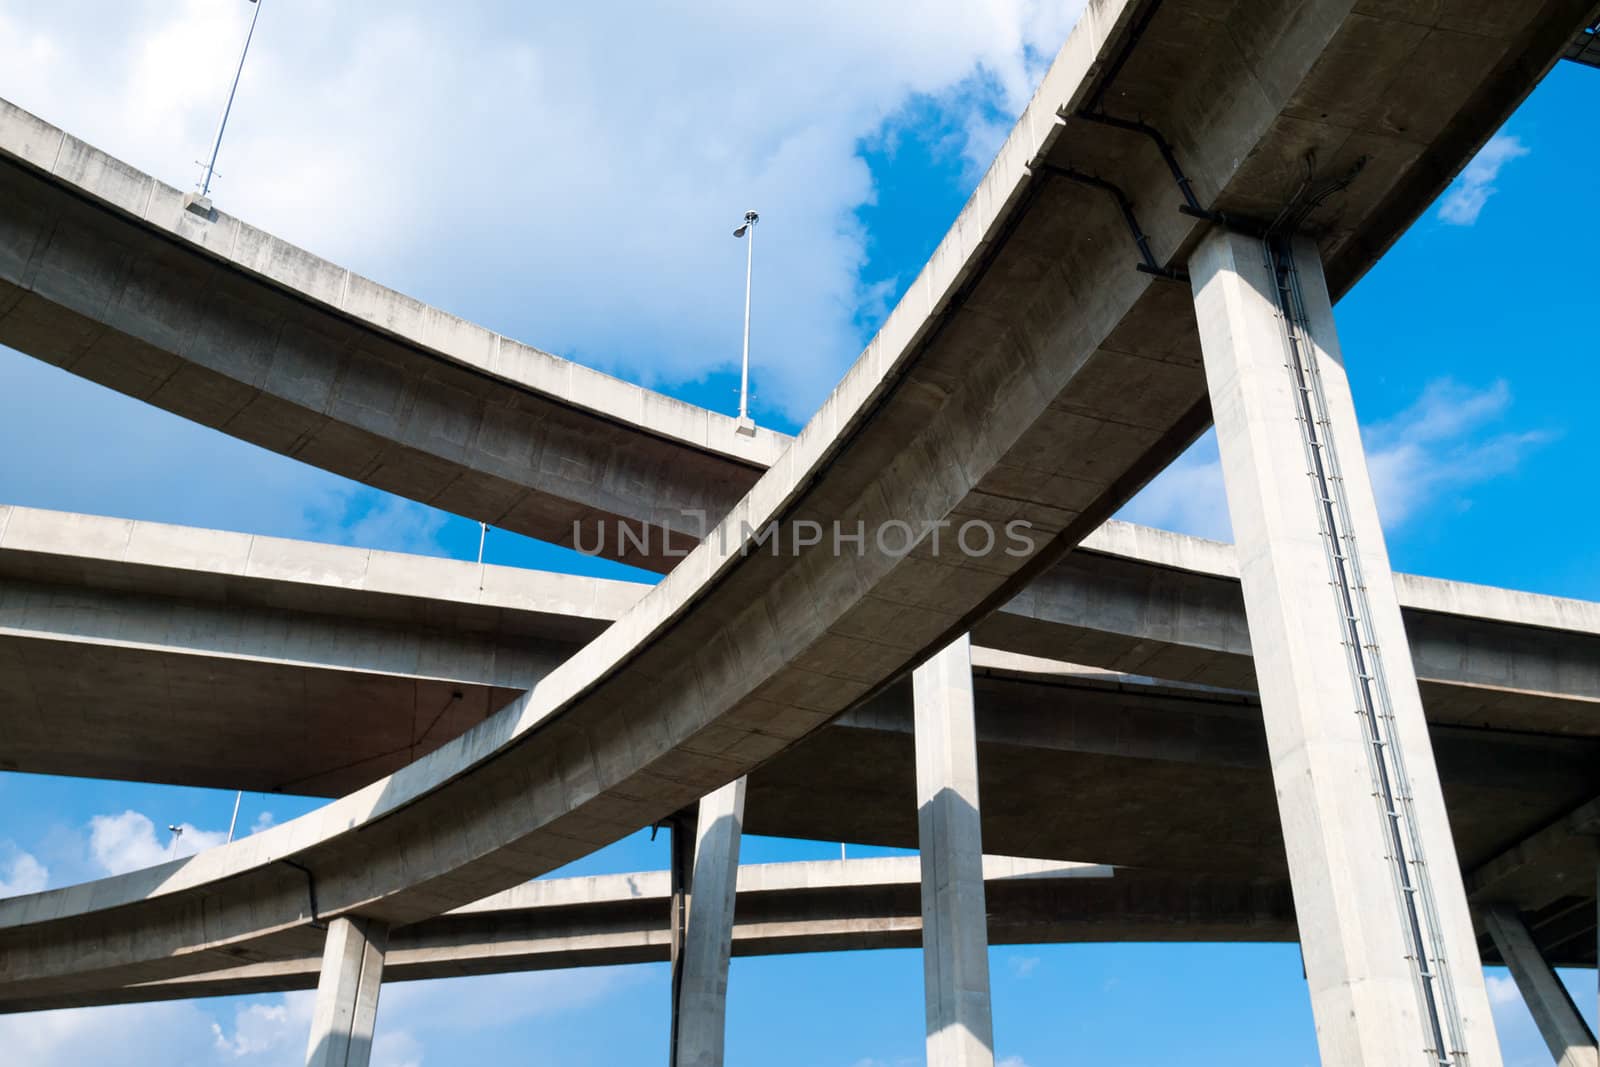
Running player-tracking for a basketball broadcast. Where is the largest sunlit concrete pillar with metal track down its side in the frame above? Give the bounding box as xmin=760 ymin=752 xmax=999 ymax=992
xmin=1189 ymin=232 xmax=1501 ymax=1067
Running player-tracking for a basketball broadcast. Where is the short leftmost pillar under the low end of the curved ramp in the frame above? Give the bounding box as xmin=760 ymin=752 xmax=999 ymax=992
xmin=306 ymin=918 xmax=389 ymax=1067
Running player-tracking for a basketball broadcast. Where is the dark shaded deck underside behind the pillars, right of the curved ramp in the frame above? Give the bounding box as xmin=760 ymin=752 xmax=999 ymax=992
xmin=746 ymin=670 xmax=1600 ymax=934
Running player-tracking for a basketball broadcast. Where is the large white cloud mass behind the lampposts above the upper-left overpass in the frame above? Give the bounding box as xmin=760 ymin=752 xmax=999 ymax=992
xmin=0 ymin=0 xmax=1082 ymax=418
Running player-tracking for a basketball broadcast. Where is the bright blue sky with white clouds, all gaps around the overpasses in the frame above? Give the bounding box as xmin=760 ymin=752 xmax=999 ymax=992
xmin=0 ymin=0 xmax=1600 ymax=1067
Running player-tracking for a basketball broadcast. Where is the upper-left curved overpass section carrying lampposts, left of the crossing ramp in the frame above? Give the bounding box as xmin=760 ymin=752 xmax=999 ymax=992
xmin=0 ymin=119 xmax=787 ymax=569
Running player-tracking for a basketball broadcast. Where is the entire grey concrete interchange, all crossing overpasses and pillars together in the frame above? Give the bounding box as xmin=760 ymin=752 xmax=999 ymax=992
xmin=0 ymin=0 xmax=1600 ymax=1067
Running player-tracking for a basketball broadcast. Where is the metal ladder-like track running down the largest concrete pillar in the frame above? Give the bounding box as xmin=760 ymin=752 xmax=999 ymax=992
xmin=1262 ymin=238 xmax=1467 ymax=1067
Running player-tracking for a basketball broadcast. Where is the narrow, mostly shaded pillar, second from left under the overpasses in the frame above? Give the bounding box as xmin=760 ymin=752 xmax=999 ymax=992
xmin=672 ymin=777 xmax=744 ymax=1067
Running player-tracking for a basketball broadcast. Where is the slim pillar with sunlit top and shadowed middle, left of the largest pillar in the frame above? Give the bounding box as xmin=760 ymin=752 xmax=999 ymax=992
xmin=912 ymin=635 xmax=995 ymax=1067
